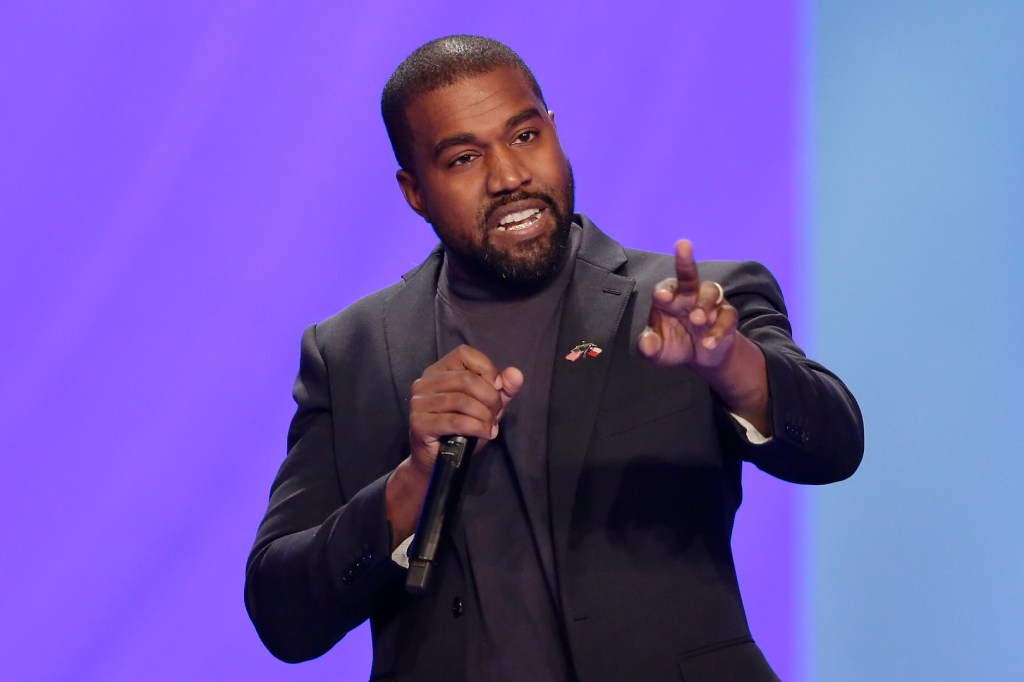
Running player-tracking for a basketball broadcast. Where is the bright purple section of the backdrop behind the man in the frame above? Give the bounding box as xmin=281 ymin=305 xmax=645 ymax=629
xmin=0 ymin=0 xmax=806 ymax=680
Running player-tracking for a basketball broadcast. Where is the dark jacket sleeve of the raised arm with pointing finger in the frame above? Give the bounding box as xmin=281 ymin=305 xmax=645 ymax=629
xmin=722 ymin=262 xmax=864 ymax=483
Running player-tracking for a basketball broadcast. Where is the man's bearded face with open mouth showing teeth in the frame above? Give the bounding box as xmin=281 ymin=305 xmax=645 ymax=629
xmin=398 ymin=68 xmax=572 ymax=286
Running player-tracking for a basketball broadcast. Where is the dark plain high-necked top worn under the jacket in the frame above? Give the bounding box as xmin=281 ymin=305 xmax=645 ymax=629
xmin=434 ymin=225 xmax=582 ymax=682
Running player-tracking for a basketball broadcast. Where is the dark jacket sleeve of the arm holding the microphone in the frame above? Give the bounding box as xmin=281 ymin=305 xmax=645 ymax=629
xmin=245 ymin=326 xmax=404 ymax=663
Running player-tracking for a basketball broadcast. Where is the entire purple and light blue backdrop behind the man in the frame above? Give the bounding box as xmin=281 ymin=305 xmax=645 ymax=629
xmin=0 ymin=0 xmax=1024 ymax=682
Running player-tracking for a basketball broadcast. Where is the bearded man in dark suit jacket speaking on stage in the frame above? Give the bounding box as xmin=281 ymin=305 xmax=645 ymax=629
xmin=246 ymin=36 xmax=863 ymax=681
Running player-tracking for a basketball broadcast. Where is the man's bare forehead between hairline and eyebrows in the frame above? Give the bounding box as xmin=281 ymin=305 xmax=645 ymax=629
xmin=406 ymin=67 xmax=544 ymax=148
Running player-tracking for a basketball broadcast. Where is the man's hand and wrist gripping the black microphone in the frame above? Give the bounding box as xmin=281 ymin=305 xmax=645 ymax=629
xmin=385 ymin=345 xmax=523 ymax=549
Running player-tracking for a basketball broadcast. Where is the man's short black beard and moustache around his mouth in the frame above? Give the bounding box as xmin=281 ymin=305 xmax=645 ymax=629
xmin=445 ymin=166 xmax=575 ymax=293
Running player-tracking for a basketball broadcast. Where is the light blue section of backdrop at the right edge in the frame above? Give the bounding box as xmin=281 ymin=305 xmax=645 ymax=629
xmin=804 ymin=0 xmax=1024 ymax=682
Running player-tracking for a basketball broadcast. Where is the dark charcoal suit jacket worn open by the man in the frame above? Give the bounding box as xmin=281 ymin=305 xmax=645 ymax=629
xmin=246 ymin=216 xmax=863 ymax=681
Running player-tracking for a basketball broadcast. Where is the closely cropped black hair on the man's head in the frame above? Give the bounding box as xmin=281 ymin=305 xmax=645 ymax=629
xmin=381 ymin=35 xmax=547 ymax=170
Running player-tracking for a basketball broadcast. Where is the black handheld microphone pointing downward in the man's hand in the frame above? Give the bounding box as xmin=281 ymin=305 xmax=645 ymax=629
xmin=406 ymin=436 xmax=476 ymax=594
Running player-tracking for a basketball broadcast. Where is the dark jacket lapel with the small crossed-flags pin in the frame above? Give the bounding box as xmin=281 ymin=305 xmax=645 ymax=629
xmin=548 ymin=218 xmax=636 ymax=561
